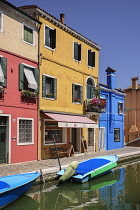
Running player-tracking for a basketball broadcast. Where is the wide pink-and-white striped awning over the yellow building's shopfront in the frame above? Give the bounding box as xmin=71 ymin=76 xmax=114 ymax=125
xmin=45 ymin=113 xmax=98 ymax=128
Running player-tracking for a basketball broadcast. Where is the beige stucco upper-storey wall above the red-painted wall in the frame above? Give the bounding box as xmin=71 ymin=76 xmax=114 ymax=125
xmin=0 ymin=4 xmax=38 ymax=61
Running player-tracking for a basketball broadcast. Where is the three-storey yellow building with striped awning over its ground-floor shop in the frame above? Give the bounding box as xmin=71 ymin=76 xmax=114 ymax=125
xmin=21 ymin=6 xmax=100 ymax=159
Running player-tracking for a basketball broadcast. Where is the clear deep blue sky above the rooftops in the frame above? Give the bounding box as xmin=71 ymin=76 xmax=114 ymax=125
xmin=7 ymin=0 xmax=140 ymax=89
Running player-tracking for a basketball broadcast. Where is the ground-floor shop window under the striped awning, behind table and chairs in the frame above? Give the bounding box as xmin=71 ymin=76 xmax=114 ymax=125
xmin=44 ymin=121 xmax=66 ymax=145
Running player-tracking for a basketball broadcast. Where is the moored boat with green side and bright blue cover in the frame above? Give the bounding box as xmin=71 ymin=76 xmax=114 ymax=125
xmin=57 ymin=155 xmax=118 ymax=183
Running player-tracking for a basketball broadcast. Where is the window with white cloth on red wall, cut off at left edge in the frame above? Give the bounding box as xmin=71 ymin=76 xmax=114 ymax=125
xmin=0 ymin=57 xmax=7 ymax=87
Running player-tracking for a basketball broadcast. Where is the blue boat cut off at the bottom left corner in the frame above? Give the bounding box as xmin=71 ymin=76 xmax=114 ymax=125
xmin=0 ymin=172 xmax=41 ymax=209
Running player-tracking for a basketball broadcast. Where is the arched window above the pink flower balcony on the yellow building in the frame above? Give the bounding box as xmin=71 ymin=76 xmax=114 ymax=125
xmin=86 ymin=78 xmax=95 ymax=99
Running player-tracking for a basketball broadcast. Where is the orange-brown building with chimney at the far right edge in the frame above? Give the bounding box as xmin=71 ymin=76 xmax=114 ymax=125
xmin=124 ymin=77 xmax=140 ymax=142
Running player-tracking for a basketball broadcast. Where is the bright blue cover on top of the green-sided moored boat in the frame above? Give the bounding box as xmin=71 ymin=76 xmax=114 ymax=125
xmin=75 ymin=158 xmax=110 ymax=175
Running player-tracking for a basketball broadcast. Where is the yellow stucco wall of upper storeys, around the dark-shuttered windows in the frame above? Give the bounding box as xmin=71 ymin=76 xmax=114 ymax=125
xmin=40 ymin=19 xmax=99 ymax=114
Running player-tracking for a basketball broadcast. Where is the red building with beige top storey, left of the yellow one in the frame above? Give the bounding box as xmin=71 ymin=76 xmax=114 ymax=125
xmin=0 ymin=0 xmax=40 ymax=163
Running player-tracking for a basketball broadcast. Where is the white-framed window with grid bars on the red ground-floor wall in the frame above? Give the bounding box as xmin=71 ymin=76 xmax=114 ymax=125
xmin=18 ymin=118 xmax=34 ymax=145
